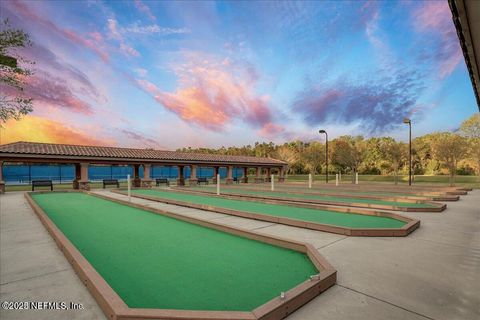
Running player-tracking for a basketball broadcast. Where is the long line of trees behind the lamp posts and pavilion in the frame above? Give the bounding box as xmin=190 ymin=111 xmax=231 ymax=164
xmin=177 ymin=113 xmax=480 ymax=183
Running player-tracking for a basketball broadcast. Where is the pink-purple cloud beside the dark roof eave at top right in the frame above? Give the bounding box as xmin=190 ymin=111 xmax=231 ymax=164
xmin=413 ymin=1 xmax=463 ymax=79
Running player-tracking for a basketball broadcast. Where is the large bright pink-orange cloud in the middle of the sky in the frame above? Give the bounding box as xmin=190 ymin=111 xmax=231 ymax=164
xmin=136 ymin=53 xmax=282 ymax=133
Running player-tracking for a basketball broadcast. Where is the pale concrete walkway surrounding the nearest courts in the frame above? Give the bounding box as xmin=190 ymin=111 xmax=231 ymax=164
xmin=0 ymin=190 xmax=480 ymax=320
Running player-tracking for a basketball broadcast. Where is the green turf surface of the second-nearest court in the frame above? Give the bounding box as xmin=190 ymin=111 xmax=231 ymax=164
xmin=132 ymin=189 xmax=406 ymax=228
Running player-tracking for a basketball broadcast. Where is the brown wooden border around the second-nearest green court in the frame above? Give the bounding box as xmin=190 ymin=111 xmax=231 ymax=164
xmin=110 ymin=189 xmax=420 ymax=237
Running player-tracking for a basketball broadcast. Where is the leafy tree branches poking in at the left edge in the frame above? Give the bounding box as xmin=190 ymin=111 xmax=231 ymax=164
xmin=0 ymin=19 xmax=33 ymax=127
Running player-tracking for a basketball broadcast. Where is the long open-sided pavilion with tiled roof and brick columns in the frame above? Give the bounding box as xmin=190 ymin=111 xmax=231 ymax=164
xmin=0 ymin=141 xmax=287 ymax=193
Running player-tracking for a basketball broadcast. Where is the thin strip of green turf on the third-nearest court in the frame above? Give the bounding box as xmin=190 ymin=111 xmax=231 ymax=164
xmin=192 ymin=187 xmax=434 ymax=208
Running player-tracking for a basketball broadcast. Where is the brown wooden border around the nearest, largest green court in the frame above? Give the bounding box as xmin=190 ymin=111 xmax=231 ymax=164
xmin=25 ymin=190 xmax=337 ymax=320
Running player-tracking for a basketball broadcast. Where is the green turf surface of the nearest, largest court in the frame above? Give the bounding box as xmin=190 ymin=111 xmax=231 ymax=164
xmin=32 ymin=193 xmax=318 ymax=311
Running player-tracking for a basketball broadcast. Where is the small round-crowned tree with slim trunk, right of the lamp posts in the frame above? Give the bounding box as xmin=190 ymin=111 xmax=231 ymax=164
xmin=432 ymin=132 xmax=468 ymax=186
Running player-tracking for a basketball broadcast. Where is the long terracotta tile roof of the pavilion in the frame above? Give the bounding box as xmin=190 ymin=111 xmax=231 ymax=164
xmin=0 ymin=141 xmax=286 ymax=165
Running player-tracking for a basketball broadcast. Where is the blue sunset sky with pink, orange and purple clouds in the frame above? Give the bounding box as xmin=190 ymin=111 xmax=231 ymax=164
xmin=0 ymin=0 xmax=478 ymax=149
